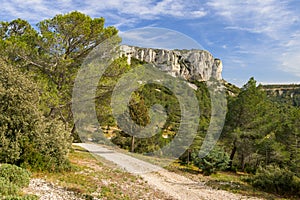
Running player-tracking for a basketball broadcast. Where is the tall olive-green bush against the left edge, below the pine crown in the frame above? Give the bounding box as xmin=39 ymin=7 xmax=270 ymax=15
xmin=0 ymin=59 xmax=40 ymax=163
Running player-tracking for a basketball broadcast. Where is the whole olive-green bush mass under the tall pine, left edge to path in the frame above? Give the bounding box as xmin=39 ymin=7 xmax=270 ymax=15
xmin=0 ymin=60 xmax=71 ymax=171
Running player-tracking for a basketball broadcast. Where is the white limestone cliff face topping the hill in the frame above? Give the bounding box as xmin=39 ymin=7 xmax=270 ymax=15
xmin=121 ymin=45 xmax=223 ymax=81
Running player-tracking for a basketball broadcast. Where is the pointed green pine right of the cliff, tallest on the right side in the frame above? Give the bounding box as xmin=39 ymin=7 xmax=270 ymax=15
xmin=222 ymin=78 xmax=272 ymax=170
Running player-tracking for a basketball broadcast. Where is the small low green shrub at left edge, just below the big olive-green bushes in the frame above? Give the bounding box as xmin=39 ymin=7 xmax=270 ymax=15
xmin=0 ymin=164 xmax=30 ymax=188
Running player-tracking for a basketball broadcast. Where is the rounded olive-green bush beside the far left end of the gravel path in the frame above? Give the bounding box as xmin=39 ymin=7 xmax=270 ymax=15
xmin=21 ymin=119 xmax=71 ymax=171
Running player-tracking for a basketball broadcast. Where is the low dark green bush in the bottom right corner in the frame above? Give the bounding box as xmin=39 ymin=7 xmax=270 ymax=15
xmin=248 ymin=165 xmax=300 ymax=196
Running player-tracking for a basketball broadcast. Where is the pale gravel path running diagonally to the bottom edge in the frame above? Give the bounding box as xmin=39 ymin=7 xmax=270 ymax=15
xmin=76 ymin=143 xmax=258 ymax=200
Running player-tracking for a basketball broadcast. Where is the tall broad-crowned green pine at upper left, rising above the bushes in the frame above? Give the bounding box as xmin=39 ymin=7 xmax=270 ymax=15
xmin=0 ymin=11 xmax=118 ymax=138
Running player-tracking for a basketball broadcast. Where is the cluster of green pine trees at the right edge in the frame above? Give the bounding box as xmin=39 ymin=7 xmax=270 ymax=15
xmin=222 ymin=78 xmax=300 ymax=174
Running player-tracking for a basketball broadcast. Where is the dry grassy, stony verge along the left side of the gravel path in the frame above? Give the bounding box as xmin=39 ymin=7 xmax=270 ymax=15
xmin=32 ymin=146 xmax=167 ymax=200
